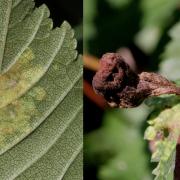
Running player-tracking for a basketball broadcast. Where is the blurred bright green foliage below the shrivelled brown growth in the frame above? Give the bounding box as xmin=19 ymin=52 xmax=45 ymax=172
xmin=84 ymin=107 xmax=151 ymax=180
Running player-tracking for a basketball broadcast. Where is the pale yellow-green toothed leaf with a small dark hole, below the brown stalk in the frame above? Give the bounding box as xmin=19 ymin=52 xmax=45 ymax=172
xmin=145 ymin=95 xmax=180 ymax=180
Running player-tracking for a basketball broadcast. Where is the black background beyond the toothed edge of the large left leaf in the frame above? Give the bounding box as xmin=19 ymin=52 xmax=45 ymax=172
xmin=35 ymin=0 xmax=83 ymax=54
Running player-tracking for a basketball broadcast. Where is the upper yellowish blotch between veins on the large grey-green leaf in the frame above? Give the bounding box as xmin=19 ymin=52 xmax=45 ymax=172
xmin=0 ymin=48 xmax=43 ymax=108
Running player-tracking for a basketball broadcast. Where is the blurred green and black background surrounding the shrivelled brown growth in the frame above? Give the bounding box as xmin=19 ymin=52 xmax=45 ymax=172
xmin=83 ymin=0 xmax=180 ymax=180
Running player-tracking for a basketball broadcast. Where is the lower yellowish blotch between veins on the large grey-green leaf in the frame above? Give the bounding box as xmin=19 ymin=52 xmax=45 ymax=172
xmin=0 ymin=86 xmax=46 ymax=148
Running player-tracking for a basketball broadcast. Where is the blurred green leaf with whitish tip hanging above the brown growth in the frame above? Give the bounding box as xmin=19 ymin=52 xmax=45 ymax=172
xmin=135 ymin=0 xmax=179 ymax=53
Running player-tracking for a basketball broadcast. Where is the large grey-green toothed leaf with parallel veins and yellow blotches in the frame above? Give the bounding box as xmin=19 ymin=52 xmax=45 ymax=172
xmin=0 ymin=0 xmax=82 ymax=180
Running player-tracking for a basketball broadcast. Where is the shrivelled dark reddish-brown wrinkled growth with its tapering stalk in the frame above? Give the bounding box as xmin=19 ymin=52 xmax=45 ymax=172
xmin=92 ymin=53 xmax=180 ymax=108
